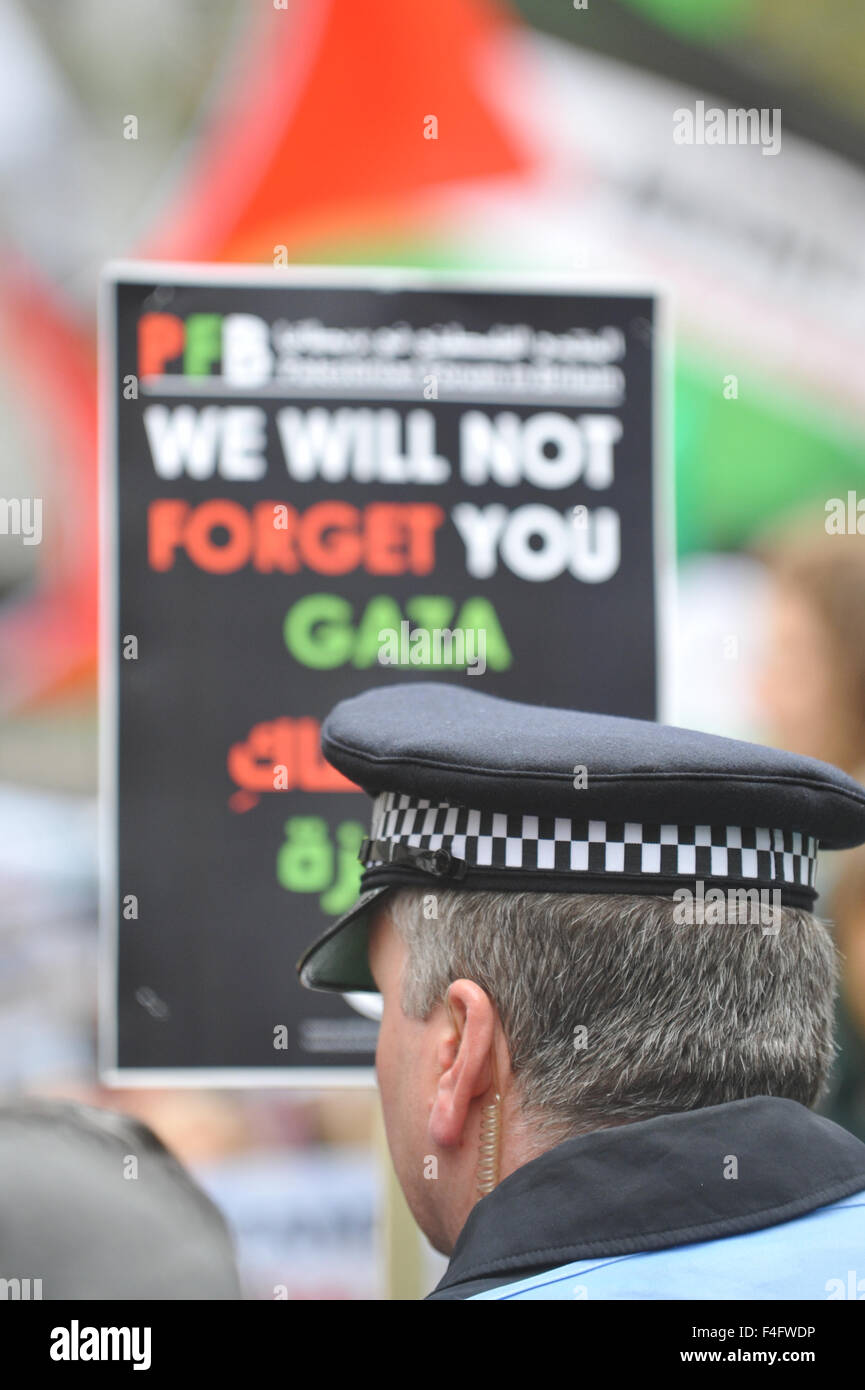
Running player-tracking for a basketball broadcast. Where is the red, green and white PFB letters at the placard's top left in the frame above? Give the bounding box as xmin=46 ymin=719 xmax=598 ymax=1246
xmin=138 ymin=313 xmax=274 ymax=386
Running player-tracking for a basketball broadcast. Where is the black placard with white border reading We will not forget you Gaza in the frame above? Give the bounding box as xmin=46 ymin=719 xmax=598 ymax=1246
xmin=102 ymin=263 xmax=666 ymax=1084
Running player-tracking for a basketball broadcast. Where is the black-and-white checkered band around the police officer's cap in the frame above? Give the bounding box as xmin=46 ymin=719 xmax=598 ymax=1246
xmin=366 ymin=792 xmax=818 ymax=888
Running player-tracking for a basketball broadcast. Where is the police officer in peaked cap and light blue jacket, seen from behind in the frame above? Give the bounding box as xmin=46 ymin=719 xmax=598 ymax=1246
xmin=298 ymin=682 xmax=865 ymax=1300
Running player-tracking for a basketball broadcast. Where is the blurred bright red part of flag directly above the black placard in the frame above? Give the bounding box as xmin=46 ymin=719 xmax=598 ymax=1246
xmin=145 ymin=0 xmax=528 ymax=261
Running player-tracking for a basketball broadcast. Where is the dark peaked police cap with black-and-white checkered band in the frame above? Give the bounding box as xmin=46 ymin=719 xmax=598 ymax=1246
xmin=298 ymin=682 xmax=865 ymax=991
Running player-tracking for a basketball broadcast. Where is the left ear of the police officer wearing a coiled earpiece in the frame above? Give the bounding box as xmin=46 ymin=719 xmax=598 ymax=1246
xmin=430 ymin=980 xmax=496 ymax=1148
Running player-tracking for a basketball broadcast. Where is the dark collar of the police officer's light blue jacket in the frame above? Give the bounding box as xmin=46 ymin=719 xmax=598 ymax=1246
xmin=430 ymin=1095 xmax=865 ymax=1298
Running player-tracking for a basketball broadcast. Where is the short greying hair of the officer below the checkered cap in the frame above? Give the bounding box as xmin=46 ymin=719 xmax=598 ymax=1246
xmin=387 ymin=890 xmax=837 ymax=1138
